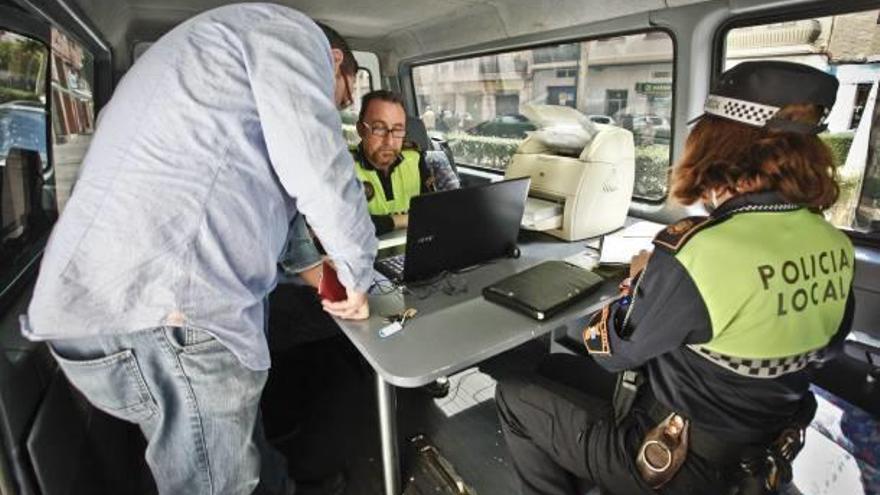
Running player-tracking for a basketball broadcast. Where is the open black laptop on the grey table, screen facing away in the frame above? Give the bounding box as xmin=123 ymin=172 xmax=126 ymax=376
xmin=376 ymin=177 xmax=530 ymax=282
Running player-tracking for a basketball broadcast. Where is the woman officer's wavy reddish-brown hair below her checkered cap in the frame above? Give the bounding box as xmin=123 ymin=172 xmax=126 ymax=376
xmin=672 ymin=104 xmax=840 ymax=210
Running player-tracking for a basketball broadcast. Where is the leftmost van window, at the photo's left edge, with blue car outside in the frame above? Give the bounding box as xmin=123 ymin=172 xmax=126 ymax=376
xmin=0 ymin=30 xmax=49 ymax=287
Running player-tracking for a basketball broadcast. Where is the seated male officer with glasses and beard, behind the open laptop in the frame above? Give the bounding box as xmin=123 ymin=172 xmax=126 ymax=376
xmin=352 ymin=89 xmax=458 ymax=235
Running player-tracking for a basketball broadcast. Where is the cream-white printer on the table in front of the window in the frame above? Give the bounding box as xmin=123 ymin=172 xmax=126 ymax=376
xmin=504 ymin=105 xmax=635 ymax=241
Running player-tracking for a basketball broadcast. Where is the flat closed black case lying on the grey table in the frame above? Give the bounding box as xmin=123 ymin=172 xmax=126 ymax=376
xmin=483 ymin=261 xmax=604 ymax=320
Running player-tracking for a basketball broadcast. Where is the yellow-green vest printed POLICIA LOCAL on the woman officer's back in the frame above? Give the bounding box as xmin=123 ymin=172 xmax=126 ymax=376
xmin=649 ymin=205 xmax=855 ymax=378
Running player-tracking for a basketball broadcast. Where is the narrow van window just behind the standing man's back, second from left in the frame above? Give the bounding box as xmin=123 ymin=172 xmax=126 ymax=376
xmin=51 ymin=28 xmax=95 ymax=212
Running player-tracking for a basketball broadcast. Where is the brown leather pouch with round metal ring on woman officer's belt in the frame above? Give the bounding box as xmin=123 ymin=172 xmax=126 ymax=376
xmin=636 ymin=412 xmax=690 ymax=490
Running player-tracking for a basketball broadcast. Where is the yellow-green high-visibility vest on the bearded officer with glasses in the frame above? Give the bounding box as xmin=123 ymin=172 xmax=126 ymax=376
xmin=353 ymin=150 xmax=421 ymax=215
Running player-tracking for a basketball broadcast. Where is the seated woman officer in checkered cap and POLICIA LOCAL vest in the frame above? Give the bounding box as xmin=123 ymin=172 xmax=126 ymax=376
xmin=496 ymin=62 xmax=854 ymax=495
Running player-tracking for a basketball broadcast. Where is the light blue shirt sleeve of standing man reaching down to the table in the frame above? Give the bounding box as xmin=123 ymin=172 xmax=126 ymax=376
xmin=244 ymin=16 xmax=376 ymax=292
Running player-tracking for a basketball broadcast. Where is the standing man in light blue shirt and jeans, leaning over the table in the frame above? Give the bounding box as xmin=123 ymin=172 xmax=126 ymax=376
xmin=22 ymin=4 xmax=376 ymax=494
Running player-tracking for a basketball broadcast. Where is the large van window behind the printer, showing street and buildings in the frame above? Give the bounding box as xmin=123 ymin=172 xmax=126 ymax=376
xmin=412 ymin=31 xmax=674 ymax=200
